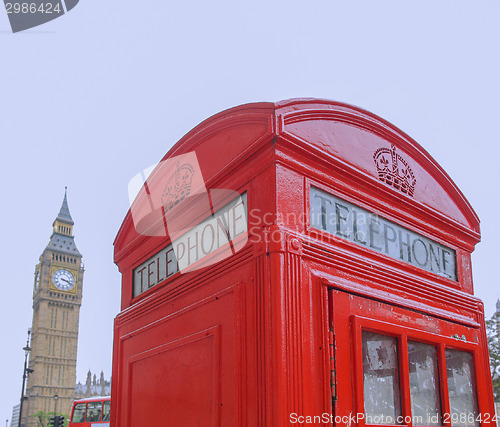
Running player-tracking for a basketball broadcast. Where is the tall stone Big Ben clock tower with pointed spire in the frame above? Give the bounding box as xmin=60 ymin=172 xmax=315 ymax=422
xmin=22 ymin=192 xmax=84 ymax=426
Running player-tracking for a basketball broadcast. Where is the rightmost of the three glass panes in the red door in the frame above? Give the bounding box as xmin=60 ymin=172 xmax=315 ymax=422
xmin=446 ymin=349 xmax=479 ymax=427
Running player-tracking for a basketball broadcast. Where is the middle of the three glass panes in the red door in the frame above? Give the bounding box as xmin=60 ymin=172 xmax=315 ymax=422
xmin=408 ymin=341 xmax=441 ymax=426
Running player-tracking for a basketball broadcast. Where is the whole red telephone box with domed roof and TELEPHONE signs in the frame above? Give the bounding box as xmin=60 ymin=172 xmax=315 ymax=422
xmin=111 ymin=99 xmax=496 ymax=427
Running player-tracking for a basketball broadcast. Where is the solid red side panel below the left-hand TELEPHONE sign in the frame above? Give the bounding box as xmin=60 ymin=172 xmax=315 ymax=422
xmin=112 ymin=285 xmax=245 ymax=426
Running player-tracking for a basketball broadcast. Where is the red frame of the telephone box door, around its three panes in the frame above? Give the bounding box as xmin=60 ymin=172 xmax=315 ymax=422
xmin=328 ymin=287 xmax=494 ymax=427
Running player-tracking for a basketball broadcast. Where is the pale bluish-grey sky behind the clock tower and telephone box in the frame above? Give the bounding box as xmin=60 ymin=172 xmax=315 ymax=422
xmin=0 ymin=0 xmax=500 ymax=422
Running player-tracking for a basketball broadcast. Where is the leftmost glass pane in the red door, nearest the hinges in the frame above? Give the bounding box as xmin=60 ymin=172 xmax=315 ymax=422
xmin=362 ymin=331 xmax=401 ymax=424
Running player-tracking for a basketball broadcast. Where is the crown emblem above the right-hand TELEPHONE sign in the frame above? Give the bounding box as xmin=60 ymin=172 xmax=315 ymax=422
xmin=373 ymin=145 xmax=417 ymax=196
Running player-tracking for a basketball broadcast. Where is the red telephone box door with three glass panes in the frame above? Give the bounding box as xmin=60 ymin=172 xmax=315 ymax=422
xmin=329 ymin=289 xmax=494 ymax=427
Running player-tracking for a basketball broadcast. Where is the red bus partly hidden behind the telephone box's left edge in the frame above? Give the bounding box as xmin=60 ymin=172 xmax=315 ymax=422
xmin=68 ymin=396 xmax=111 ymax=427
